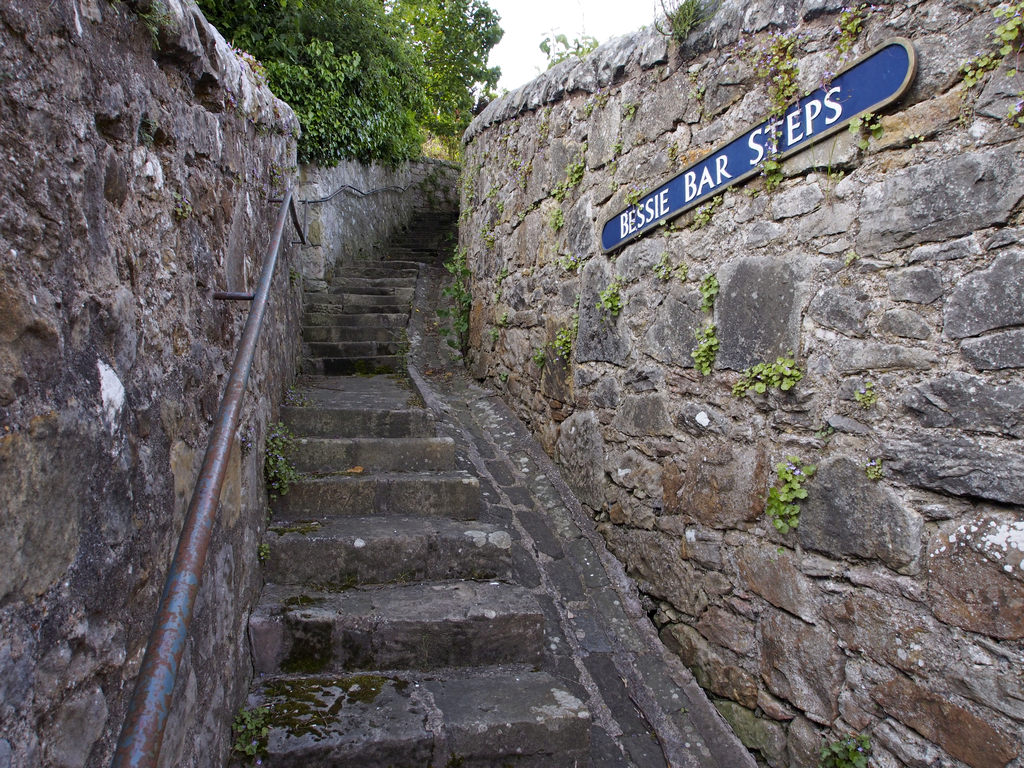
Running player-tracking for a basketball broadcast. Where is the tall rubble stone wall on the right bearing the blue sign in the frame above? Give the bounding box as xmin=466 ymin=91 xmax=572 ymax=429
xmin=460 ymin=0 xmax=1024 ymax=768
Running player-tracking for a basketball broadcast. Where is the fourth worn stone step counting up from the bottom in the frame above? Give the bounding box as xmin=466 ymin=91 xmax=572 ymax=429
xmin=270 ymin=471 xmax=480 ymax=520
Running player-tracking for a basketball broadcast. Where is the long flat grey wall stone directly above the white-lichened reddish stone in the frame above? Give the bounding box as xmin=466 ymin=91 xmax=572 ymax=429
xmin=882 ymin=435 xmax=1024 ymax=504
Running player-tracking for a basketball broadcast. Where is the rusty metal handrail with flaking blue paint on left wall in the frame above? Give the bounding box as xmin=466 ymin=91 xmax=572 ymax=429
xmin=112 ymin=189 xmax=306 ymax=768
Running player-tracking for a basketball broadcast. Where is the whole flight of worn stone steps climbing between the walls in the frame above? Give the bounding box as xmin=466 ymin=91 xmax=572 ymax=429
xmin=240 ymin=257 xmax=591 ymax=768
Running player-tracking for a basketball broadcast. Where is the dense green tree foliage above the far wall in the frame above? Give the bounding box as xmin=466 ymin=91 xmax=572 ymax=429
xmin=200 ymin=0 xmax=502 ymax=165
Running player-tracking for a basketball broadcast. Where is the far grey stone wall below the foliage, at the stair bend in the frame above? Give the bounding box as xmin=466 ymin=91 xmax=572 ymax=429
xmin=300 ymin=159 xmax=459 ymax=280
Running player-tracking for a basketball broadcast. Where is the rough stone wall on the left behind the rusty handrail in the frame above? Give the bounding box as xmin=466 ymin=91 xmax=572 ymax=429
xmin=0 ymin=0 xmax=300 ymax=768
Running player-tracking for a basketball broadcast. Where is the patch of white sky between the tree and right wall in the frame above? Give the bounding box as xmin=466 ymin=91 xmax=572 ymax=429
xmin=487 ymin=0 xmax=660 ymax=92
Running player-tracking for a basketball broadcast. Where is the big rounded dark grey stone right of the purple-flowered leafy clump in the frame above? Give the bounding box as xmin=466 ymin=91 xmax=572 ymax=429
xmin=797 ymin=456 xmax=923 ymax=568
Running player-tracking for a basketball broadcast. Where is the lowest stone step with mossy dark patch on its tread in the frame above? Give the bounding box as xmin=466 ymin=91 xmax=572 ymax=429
xmin=249 ymin=670 xmax=591 ymax=768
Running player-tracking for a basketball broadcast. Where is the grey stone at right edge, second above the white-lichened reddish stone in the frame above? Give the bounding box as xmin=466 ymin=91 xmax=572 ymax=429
xmin=903 ymin=372 xmax=1024 ymax=437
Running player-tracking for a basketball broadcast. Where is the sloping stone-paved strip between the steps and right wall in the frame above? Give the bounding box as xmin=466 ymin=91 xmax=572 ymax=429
xmin=409 ymin=267 xmax=756 ymax=768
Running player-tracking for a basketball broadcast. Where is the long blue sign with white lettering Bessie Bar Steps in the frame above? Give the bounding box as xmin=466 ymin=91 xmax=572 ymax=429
xmin=601 ymin=38 xmax=916 ymax=253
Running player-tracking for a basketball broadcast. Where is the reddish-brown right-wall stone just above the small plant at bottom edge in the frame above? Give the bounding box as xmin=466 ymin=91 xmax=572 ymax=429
xmin=759 ymin=611 xmax=846 ymax=724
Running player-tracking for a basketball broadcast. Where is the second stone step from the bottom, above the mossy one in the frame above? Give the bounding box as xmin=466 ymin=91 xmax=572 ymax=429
xmin=249 ymin=581 xmax=544 ymax=675
